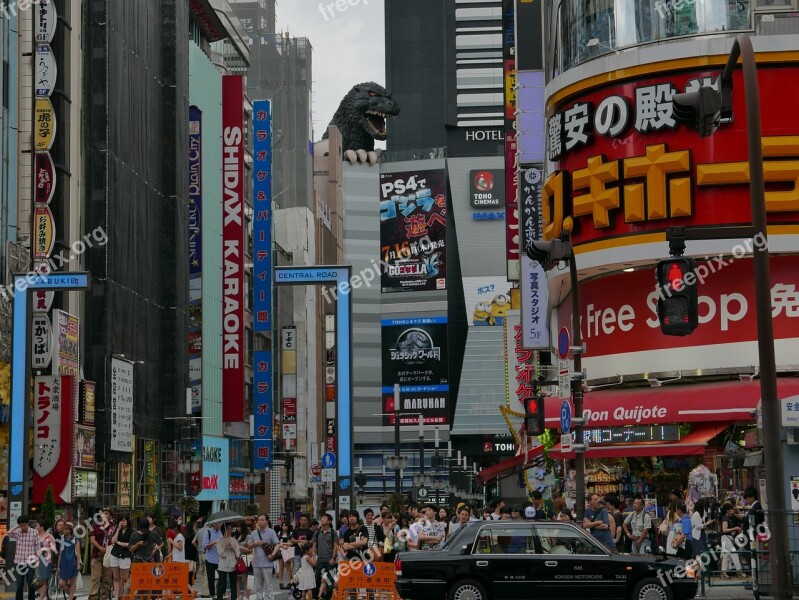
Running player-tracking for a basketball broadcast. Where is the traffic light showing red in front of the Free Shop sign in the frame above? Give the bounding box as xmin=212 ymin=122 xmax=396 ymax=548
xmin=655 ymin=257 xmax=699 ymax=335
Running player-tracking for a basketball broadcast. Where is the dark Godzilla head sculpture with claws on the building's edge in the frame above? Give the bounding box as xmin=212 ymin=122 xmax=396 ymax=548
xmin=323 ymin=81 xmax=399 ymax=164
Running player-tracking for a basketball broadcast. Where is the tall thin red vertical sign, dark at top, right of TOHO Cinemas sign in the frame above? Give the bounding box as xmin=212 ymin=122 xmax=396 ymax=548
xmin=502 ymin=0 xmax=519 ymax=281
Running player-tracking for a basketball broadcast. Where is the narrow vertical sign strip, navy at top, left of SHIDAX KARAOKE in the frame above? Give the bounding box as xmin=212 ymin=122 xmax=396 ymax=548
xmin=189 ymin=106 xmax=203 ymax=414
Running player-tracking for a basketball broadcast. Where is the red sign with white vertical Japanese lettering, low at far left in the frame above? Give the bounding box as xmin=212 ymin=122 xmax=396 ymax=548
xmin=31 ymin=375 xmax=75 ymax=504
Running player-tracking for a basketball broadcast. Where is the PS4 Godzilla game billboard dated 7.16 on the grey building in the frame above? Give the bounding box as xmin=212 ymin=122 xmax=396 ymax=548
xmin=380 ymin=169 xmax=447 ymax=292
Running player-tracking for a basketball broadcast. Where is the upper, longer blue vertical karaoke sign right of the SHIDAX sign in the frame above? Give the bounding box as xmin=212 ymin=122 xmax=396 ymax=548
xmin=252 ymin=100 xmax=273 ymax=333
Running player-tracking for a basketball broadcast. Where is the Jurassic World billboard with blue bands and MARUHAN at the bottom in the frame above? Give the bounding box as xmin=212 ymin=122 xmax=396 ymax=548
xmin=381 ymin=317 xmax=450 ymax=426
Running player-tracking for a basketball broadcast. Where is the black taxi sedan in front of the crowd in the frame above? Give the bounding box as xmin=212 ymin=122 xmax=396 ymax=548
xmin=394 ymin=521 xmax=697 ymax=600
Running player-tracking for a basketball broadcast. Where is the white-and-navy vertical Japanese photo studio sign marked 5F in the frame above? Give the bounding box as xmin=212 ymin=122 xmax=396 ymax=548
xmin=519 ymin=166 xmax=550 ymax=350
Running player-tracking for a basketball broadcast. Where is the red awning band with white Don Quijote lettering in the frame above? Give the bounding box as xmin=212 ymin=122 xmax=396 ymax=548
xmin=546 ymin=378 xmax=799 ymax=429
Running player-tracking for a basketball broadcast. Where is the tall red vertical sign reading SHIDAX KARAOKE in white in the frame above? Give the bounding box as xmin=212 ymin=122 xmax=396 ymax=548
xmin=222 ymin=75 xmax=244 ymax=421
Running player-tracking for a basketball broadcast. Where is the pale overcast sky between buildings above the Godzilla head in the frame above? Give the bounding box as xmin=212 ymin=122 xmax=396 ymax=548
xmin=277 ymin=0 xmax=385 ymax=140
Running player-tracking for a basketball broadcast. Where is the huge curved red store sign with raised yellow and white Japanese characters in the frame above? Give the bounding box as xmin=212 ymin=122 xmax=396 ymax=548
xmin=548 ymin=65 xmax=799 ymax=245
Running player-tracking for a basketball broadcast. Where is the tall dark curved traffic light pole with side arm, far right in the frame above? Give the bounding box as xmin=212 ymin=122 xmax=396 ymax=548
xmin=668 ymin=34 xmax=793 ymax=600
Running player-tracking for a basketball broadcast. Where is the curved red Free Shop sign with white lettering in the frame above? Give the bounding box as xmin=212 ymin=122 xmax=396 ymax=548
xmin=558 ymin=256 xmax=799 ymax=358
